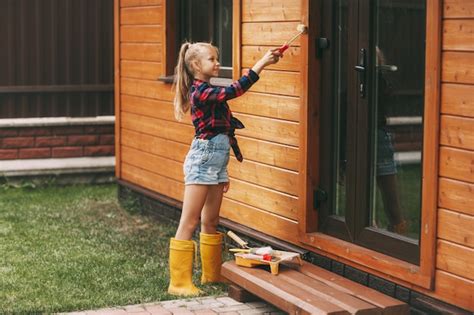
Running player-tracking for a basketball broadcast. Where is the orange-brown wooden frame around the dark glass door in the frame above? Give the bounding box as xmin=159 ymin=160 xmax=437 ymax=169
xmin=298 ymin=0 xmax=442 ymax=289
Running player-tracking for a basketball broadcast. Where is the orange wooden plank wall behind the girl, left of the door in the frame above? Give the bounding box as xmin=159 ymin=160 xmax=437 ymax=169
xmin=115 ymin=0 xmax=303 ymax=241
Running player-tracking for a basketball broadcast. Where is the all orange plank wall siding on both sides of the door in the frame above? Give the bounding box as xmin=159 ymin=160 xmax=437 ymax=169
xmin=115 ymin=0 xmax=474 ymax=309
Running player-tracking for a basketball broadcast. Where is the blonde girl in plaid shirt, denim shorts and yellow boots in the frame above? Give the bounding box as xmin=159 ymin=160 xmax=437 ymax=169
xmin=168 ymin=43 xmax=282 ymax=295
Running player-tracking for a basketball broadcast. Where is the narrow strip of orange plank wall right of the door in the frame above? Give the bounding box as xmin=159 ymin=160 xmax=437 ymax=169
xmin=435 ymin=0 xmax=474 ymax=310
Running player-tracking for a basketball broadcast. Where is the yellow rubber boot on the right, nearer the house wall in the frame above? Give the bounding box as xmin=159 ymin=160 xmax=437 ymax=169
xmin=199 ymin=232 xmax=223 ymax=283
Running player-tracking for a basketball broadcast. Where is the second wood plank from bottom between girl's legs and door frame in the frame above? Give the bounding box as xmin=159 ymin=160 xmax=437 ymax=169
xmin=226 ymin=179 xmax=298 ymax=221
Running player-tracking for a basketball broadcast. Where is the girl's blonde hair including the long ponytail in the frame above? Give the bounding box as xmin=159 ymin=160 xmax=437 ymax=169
xmin=173 ymin=42 xmax=218 ymax=120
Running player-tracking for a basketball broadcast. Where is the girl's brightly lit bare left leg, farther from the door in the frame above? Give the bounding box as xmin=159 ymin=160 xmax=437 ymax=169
xmin=175 ymin=185 xmax=211 ymax=240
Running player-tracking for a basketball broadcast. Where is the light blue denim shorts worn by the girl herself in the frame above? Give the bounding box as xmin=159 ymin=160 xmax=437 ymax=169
xmin=183 ymin=134 xmax=230 ymax=185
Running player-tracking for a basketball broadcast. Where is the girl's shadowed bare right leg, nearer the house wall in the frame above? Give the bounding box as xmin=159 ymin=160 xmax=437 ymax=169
xmin=201 ymin=183 xmax=225 ymax=234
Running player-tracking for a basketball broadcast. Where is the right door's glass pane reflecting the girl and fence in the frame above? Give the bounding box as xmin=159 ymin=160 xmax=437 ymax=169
xmin=370 ymin=0 xmax=425 ymax=239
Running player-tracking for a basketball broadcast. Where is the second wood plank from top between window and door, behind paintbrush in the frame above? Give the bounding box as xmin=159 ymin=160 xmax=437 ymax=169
xmin=242 ymin=22 xmax=300 ymax=47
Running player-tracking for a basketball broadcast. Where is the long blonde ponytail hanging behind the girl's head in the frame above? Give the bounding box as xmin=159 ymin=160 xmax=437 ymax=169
xmin=174 ymin=42 xmax=194 ymax=120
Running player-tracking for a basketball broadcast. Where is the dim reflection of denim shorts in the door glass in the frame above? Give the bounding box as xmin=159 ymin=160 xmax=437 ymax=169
xmin=376 ymin=129 xmax=397 ymax=176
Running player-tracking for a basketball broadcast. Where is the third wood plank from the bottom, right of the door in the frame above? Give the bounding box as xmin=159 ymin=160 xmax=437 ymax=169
xmin=437 ymin=209 xmax=474 ymax=248
